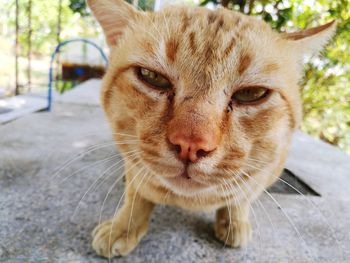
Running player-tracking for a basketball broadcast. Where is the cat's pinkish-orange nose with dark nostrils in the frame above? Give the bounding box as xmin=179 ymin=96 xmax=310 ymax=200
xmin=168 ymin=129 xmax=217 ymax=163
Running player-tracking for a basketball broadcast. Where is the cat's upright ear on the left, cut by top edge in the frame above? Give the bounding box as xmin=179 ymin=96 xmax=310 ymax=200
xmin=87 ymin=0 xmax=140 ymax=48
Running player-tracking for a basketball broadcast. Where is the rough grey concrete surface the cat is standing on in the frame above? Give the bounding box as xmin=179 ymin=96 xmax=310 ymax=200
xmin=0 ymin=81 xmax=350 ymax=263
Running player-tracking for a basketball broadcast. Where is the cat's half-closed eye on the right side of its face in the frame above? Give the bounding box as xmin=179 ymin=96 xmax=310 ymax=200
xmin=232 ymin=87 xmax=270 ymax=104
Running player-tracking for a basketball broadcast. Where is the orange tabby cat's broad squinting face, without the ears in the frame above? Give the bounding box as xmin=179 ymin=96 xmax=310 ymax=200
xmin=89 ymin=1 xmax=334 ymax=195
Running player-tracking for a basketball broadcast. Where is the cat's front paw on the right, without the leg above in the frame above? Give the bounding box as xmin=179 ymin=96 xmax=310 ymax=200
xmin=214 ymin=219 xmax=252 ymax=248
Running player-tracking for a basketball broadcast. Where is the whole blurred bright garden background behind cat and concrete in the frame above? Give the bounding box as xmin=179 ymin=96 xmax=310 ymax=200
xmin=0 ymin=0 xmax=350 ymax=153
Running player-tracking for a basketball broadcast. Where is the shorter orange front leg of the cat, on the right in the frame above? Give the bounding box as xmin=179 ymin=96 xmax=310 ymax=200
xmin=214 ymin=203 xmax=252 ymax=247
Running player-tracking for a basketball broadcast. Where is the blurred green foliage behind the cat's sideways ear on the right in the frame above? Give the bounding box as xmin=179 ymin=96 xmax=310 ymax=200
xmin=201 ymin=0 xmax=350 ymax=153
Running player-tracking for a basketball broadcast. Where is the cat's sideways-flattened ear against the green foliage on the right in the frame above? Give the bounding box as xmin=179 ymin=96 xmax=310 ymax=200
xmin=282 ymin=20 xmax=336 ymax=55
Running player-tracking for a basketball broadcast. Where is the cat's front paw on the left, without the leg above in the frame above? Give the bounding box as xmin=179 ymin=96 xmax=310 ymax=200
xmin=92 ymin=220 xmax=147 ymax=258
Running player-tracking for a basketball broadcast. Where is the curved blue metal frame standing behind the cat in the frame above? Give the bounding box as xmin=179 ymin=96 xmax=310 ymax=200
xmin=47 ymin=38 xmax=108 ymax=111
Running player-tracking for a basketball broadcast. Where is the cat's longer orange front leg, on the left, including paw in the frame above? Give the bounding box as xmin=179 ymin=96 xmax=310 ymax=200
xmin=92 ymin=186 xmax=154 ymax=257
